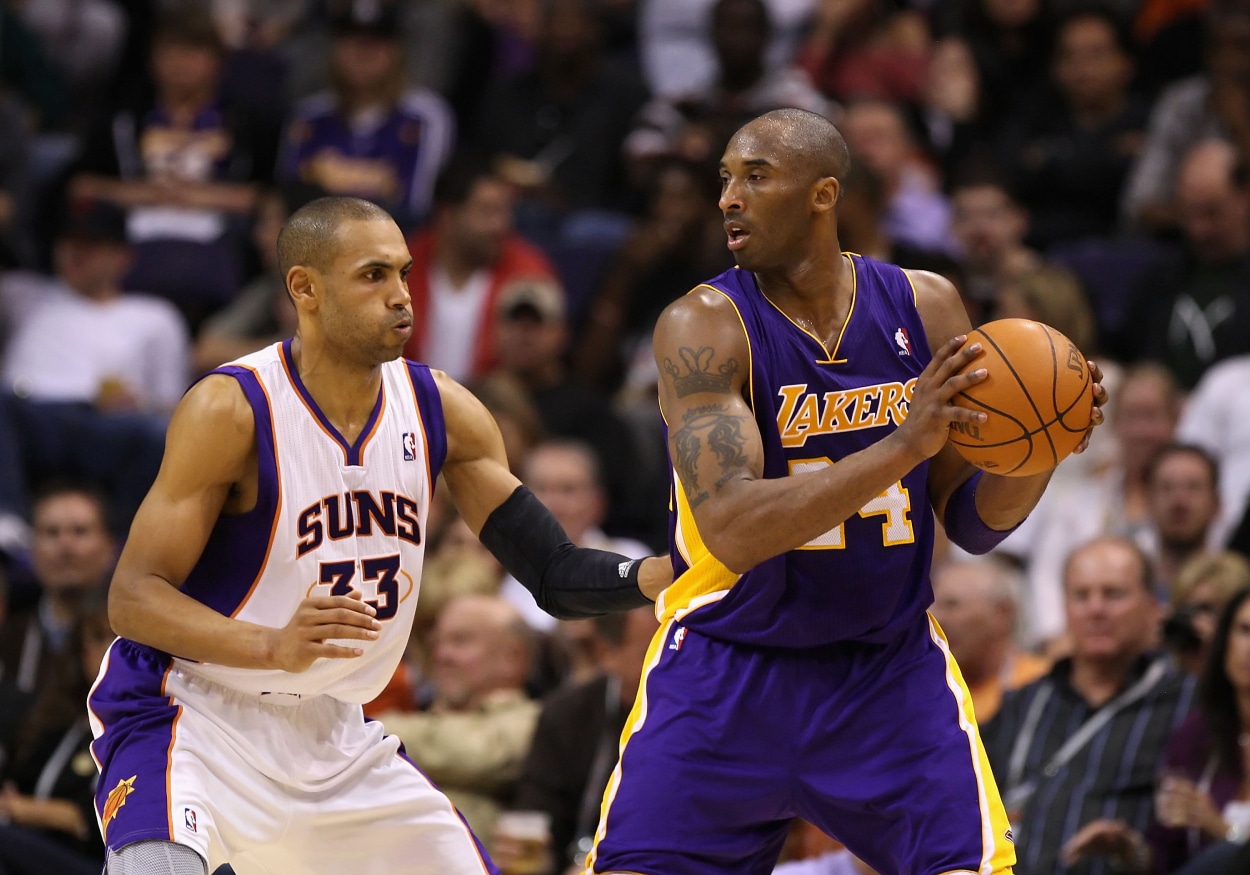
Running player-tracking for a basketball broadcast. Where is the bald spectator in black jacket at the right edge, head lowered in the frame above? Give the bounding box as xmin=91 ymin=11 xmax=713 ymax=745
xmin=1110 ymin=140 xmax=1250 ymax=390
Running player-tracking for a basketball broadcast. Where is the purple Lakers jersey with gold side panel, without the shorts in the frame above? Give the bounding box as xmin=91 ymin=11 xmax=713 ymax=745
xmin=656 ymin=255 xmax=934 ymax=648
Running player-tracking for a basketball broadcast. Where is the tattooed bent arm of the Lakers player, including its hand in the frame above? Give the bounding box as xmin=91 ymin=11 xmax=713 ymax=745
xmin=655 ymin=289 xmax=979 ymax=573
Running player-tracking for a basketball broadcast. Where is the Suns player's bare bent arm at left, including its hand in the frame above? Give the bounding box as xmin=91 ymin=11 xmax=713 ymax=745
xmin=109 ymin=375 xmax=376 ymax=671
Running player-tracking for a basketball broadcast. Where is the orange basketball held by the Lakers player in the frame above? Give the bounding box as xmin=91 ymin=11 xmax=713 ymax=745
xmin=950 ymin=319 xmax=1094 ymax=478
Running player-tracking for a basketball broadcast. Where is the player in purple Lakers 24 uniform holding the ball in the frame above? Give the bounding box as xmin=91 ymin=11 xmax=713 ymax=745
xmin=589 ymin=109 xmax=1105 ymax=875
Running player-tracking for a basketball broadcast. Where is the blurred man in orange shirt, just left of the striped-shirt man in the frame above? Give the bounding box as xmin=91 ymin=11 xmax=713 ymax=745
xmin=931 ymin=558 xmax=1050 ymax=726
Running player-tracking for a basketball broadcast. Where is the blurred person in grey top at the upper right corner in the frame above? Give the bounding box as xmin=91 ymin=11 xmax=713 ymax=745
xmin=1123 ymin=0 xmax=1250 ymax=231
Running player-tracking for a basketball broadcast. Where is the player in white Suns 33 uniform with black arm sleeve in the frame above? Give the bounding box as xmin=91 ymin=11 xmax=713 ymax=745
xmin=89 ymin=198 xmax=671 ymax=875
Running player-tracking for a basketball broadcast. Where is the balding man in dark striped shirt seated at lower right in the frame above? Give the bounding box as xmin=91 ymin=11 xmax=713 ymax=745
xmin=983 ymin=538 xmax=1194 ymax=875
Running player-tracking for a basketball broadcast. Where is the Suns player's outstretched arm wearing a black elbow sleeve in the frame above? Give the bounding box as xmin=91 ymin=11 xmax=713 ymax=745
xmin=435 ymin=371 xmax=673 ymax=607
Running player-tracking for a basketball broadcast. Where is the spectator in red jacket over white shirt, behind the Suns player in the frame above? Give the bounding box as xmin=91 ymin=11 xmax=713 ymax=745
xmin=404 ymin=161 xmax=564 ymax=381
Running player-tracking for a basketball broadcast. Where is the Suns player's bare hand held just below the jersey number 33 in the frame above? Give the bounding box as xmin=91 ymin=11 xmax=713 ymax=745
xmin=269 ymin=590 xmax=383 ymax=673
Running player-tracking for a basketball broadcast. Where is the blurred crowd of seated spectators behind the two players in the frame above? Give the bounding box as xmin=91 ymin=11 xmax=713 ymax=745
xmin=0 ymin=0 xmax=1250 ymax=875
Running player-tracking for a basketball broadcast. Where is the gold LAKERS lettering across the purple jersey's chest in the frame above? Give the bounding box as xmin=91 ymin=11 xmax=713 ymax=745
xmin=778 ymin=378 xmax=916 ymax=448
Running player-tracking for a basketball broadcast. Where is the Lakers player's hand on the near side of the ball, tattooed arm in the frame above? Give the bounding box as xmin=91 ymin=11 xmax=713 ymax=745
xmin=894 ymin=334 xmax=988 ymax=460
